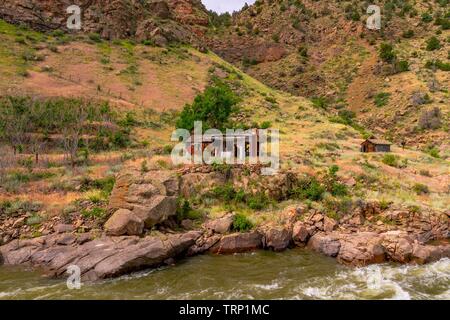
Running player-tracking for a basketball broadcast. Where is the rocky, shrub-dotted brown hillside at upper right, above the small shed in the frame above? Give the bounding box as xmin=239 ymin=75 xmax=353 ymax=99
xmin=208 ymin=0 xmax=450 ymax=152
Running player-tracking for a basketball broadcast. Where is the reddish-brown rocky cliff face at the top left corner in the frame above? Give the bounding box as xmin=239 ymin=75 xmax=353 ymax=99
xmin=0 ymin=0 xmax=208 ymax=44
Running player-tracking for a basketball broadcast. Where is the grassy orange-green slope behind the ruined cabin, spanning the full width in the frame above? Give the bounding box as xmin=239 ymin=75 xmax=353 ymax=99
xmin=0 ymin=18 xmax=450 ymax=236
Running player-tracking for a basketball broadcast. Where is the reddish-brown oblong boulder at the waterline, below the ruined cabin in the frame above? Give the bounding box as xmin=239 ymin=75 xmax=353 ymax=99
xmin=210 ymin=231 xmax=263 ymax=254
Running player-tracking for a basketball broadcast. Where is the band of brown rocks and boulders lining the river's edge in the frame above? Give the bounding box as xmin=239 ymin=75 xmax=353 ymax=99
xmin=0 ymin=166 xmax=450 ymax=281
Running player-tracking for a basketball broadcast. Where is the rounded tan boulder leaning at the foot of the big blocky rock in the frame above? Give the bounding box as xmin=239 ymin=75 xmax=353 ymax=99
xmin=105 ymin=209 xmax=144 ymax=236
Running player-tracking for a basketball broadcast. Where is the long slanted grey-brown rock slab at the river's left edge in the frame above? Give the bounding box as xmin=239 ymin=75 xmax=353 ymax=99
xmin=0 ymin=231 xmax=201 ymax=281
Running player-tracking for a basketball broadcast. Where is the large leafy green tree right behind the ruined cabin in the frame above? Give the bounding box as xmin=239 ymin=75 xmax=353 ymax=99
xmin=176 ymin=83 xmax=239 ymax=131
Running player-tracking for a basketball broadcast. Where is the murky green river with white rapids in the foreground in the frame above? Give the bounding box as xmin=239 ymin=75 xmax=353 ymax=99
xmin=0 ymin=249 xmax=450 ymax=300
